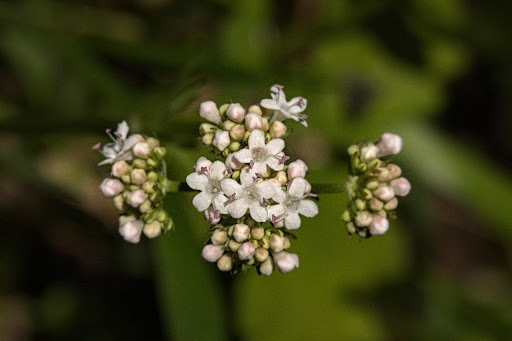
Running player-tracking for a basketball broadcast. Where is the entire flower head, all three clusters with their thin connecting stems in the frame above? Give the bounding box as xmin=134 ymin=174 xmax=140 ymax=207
xmin=93 ymin=85 xmax=411 ymax=276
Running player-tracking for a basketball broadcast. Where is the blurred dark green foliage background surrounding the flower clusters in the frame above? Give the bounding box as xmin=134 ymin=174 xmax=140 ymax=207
xmin=0 ymin=0 xmax=512 ymax=340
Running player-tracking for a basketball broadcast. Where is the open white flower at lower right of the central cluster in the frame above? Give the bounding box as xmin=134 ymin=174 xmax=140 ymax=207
xmin=268 ymin=178 xmax=318 ymax=230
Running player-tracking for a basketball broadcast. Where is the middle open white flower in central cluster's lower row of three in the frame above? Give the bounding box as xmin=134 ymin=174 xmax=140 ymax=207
xmin=221 ymin=169 xmax=276 ymax=222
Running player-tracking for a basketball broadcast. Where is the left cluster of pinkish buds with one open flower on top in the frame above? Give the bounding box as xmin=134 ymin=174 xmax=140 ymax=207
xmin=93 ymin=121 xmax=172 ymax=243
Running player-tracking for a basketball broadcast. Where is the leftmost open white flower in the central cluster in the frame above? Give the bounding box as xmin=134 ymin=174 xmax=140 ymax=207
xmin=186 ymin=159 xmax=228 ymax=214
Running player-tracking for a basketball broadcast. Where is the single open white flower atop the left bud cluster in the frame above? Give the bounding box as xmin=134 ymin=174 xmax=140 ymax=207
xmin=98 ymin=121 xmax=139 ymax=166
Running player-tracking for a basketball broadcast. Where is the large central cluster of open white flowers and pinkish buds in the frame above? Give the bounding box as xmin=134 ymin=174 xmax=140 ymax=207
xmin=186 ymin=85 xmax=318 ymax=275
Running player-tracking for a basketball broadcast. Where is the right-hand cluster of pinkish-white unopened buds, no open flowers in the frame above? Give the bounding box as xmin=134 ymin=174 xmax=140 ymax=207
xmin=342 ymin=133 xmax=411 ymax=238
